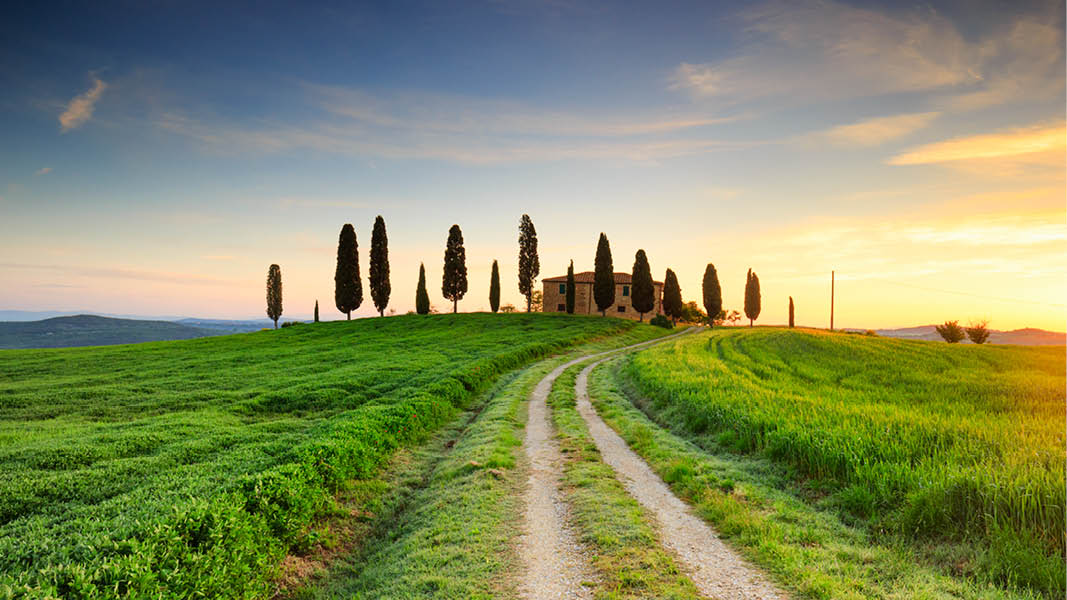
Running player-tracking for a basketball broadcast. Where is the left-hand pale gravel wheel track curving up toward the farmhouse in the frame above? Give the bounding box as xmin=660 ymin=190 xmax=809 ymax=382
xmin=517 ymin=332 xmax=686 ymax=600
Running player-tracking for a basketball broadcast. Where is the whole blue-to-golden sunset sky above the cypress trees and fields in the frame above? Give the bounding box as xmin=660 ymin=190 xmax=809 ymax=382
xmin=0 ymin=0 xmax=1067 ymax=331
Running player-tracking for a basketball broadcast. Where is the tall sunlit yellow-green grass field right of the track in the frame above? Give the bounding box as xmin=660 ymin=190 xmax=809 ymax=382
xmin=624 ymin=329 xmax=1065 ymax=597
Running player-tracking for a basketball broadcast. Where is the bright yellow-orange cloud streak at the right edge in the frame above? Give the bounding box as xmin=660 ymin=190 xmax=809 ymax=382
xmin=888 ymin=123 xmax=1067 ymax=164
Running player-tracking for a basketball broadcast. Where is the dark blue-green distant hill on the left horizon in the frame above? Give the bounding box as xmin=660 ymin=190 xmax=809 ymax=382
xmin=0 ymin=315 xmax=224 ymax=349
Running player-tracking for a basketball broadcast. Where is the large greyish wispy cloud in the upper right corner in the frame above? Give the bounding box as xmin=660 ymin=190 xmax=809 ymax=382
xmin=671 ymin=0 xmax=1064 ymax=109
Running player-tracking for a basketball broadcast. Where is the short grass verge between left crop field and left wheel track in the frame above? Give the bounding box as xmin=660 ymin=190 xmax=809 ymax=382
xmin=279 ymin=326 xmax=669 ymax=600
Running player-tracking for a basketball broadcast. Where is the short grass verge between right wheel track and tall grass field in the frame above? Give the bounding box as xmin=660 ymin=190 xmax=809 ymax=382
xmin=589 ymin=350 xmax=1038 ymax=600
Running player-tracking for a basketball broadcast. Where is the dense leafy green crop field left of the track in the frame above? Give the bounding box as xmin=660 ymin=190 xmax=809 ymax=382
xmin=0 ymin=314 xmax=634 ymax=598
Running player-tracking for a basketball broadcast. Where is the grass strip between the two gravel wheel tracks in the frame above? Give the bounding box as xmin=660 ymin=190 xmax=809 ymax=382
xmin=548 ymin=363 xmax=702 ymax=600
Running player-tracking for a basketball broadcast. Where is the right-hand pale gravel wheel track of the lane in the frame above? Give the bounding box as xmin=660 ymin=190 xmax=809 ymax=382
xmin=574 ymin=359 xmax=789 ymax=600
